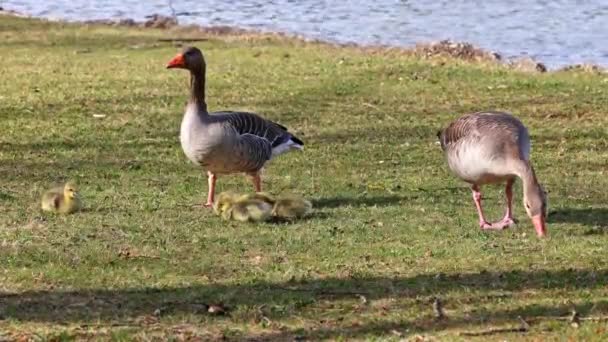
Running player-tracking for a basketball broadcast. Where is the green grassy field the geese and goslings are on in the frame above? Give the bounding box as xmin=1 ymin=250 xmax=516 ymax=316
xmin=0 ymin=12 xmax=608 ymax=341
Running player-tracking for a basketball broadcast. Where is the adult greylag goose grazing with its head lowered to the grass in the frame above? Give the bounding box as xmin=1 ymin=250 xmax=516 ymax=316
xmin=437 ymin=112 xmax=547 ymax=237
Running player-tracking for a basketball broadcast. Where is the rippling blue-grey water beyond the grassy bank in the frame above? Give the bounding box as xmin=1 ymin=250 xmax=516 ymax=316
xmin=0 ymin=0 xmax=608 ymax=68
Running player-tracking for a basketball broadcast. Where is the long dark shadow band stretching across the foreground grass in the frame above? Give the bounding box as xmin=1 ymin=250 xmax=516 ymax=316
xmin=0 ymin=269 xmax=608 ymax=339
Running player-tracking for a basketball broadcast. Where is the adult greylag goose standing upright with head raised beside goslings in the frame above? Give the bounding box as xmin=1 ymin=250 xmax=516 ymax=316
xmin=167 ymin=47 xmax=304 ymax=207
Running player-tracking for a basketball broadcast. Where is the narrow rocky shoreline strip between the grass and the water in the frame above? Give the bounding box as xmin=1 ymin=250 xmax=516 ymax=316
xmin=0 ymin=7 xmax=608 ymax=73
